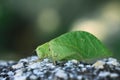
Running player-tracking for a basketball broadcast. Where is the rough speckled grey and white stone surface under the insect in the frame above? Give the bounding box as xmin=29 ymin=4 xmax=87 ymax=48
xmin=0 ymin=56 xmax=120 ymax=80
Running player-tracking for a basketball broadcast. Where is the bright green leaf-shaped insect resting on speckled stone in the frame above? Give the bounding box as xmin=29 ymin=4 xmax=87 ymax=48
xmin=36 ymin=31 xmax=112 ymax=62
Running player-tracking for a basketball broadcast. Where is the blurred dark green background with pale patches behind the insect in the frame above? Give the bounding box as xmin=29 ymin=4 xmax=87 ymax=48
xmin=0 ymin=0 xmax=120 ymax=60
